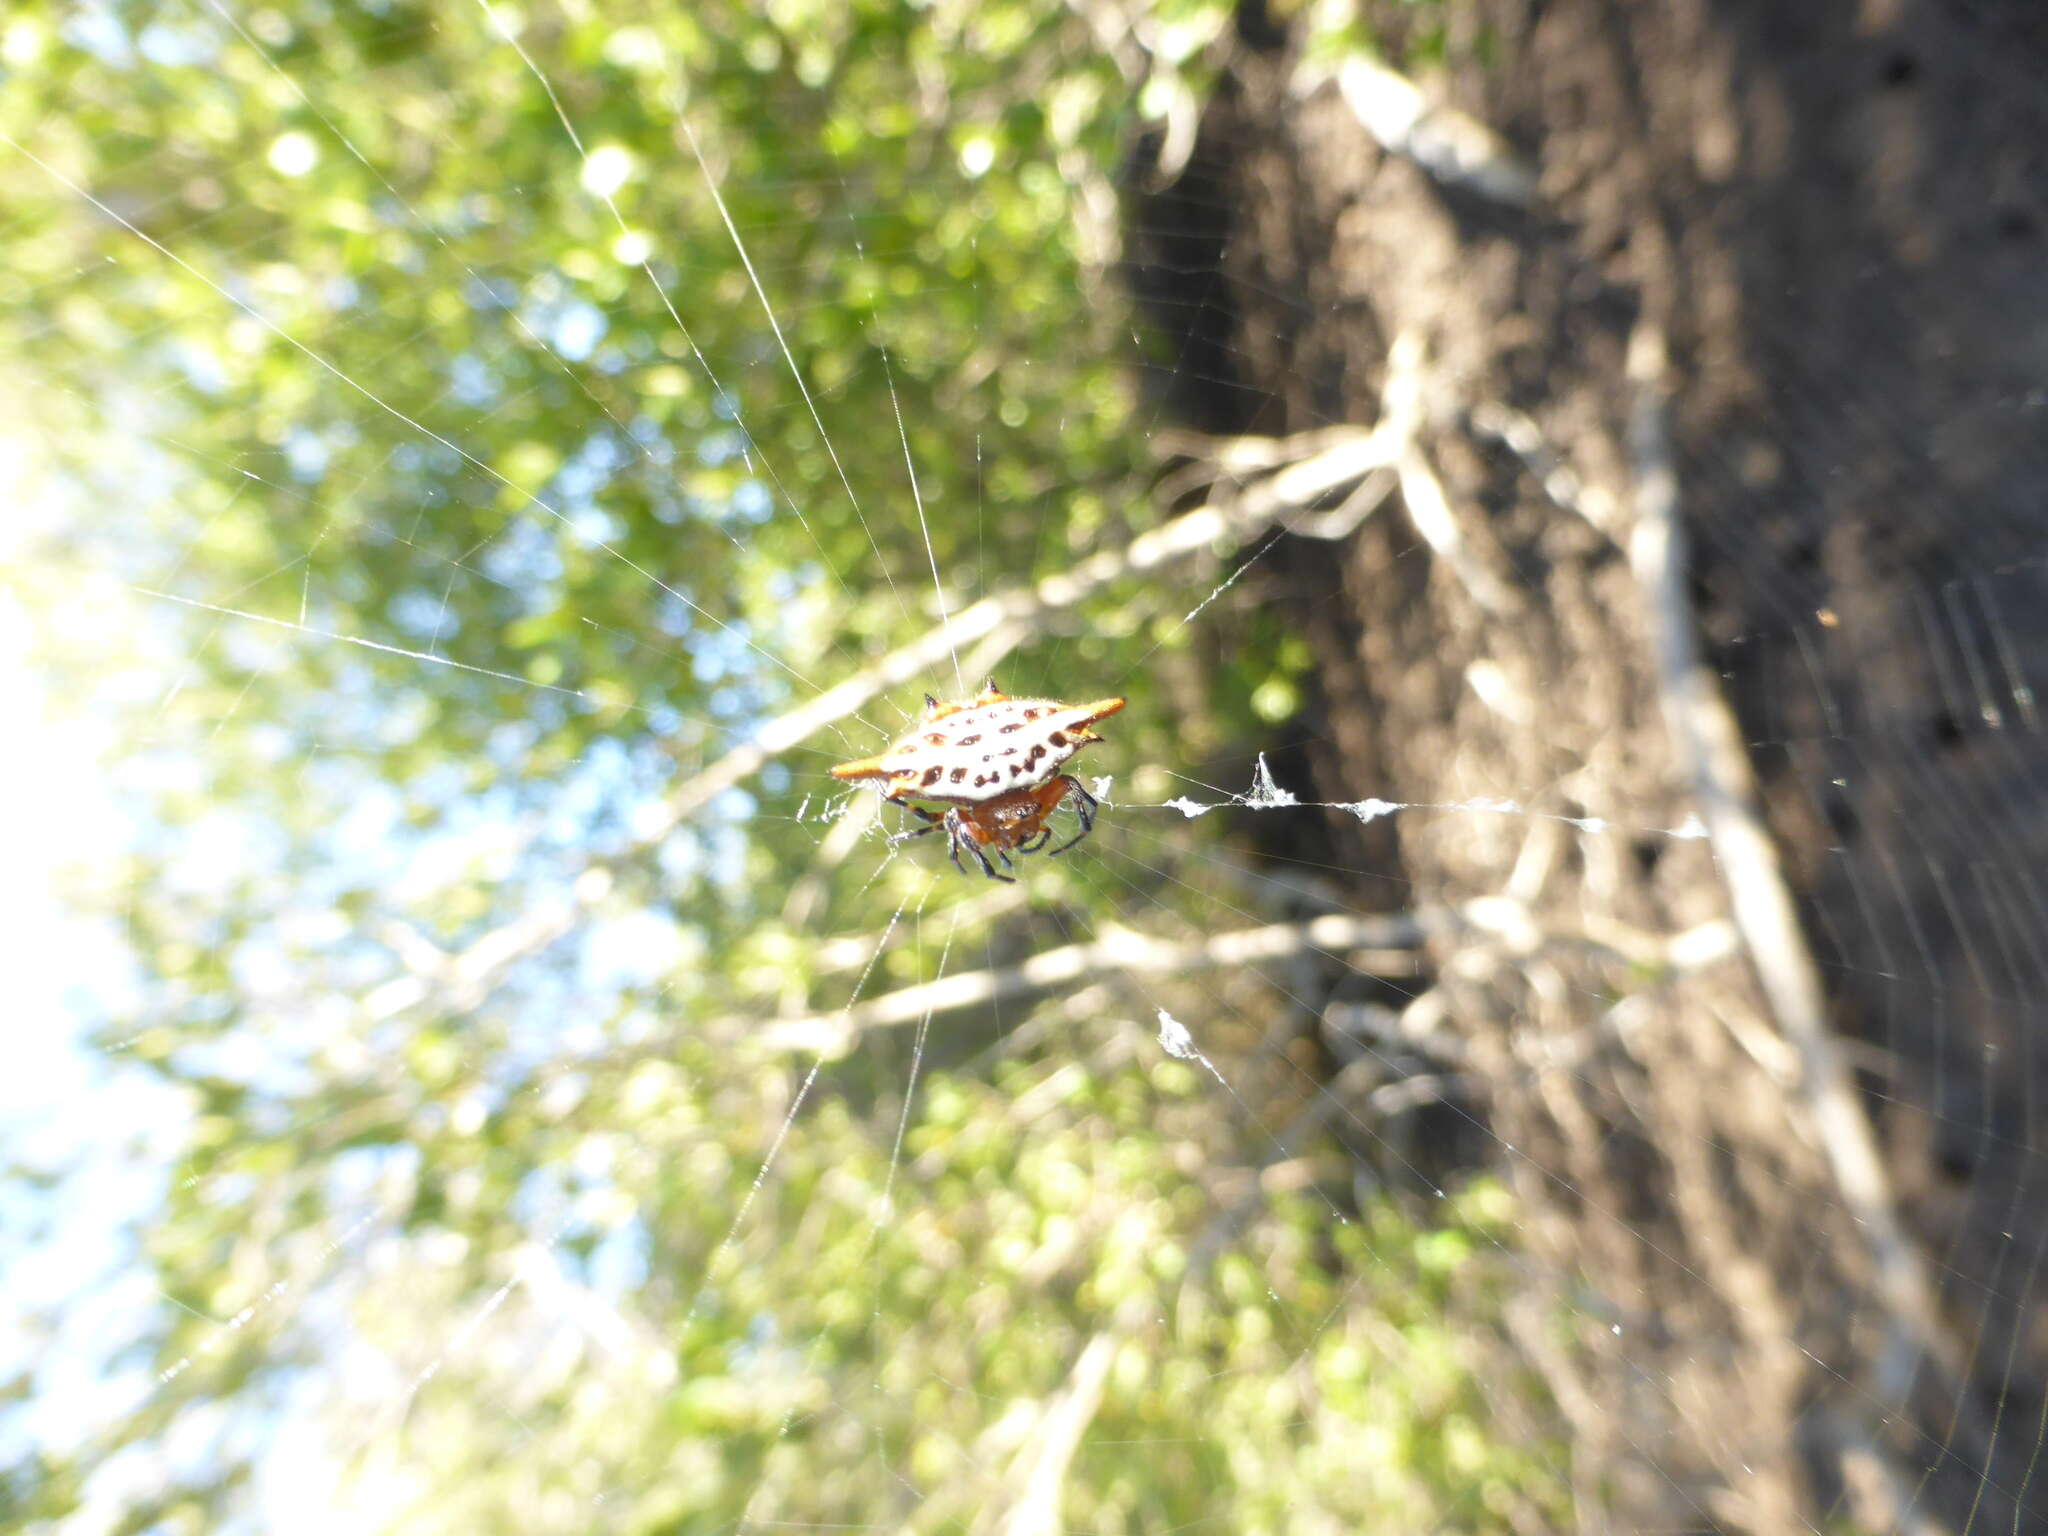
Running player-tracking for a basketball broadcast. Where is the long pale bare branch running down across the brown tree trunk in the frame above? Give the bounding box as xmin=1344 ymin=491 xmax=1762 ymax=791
xmin=1628 ymin=326 xmax=1966 ymax=1403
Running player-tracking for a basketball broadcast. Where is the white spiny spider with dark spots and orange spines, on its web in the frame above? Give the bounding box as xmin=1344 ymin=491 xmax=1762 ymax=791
xmin=831 ymin=678 xmax=1124 ymax=881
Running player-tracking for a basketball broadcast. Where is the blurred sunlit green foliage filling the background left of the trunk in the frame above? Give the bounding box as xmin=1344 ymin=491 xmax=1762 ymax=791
xmin=0 ymin=0 xmax=1561 ymax=1532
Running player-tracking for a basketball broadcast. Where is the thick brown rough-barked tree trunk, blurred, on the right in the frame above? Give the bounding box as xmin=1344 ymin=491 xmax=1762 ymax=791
xmin=1135 ymin=0 xmax=2048 ymax=1532
